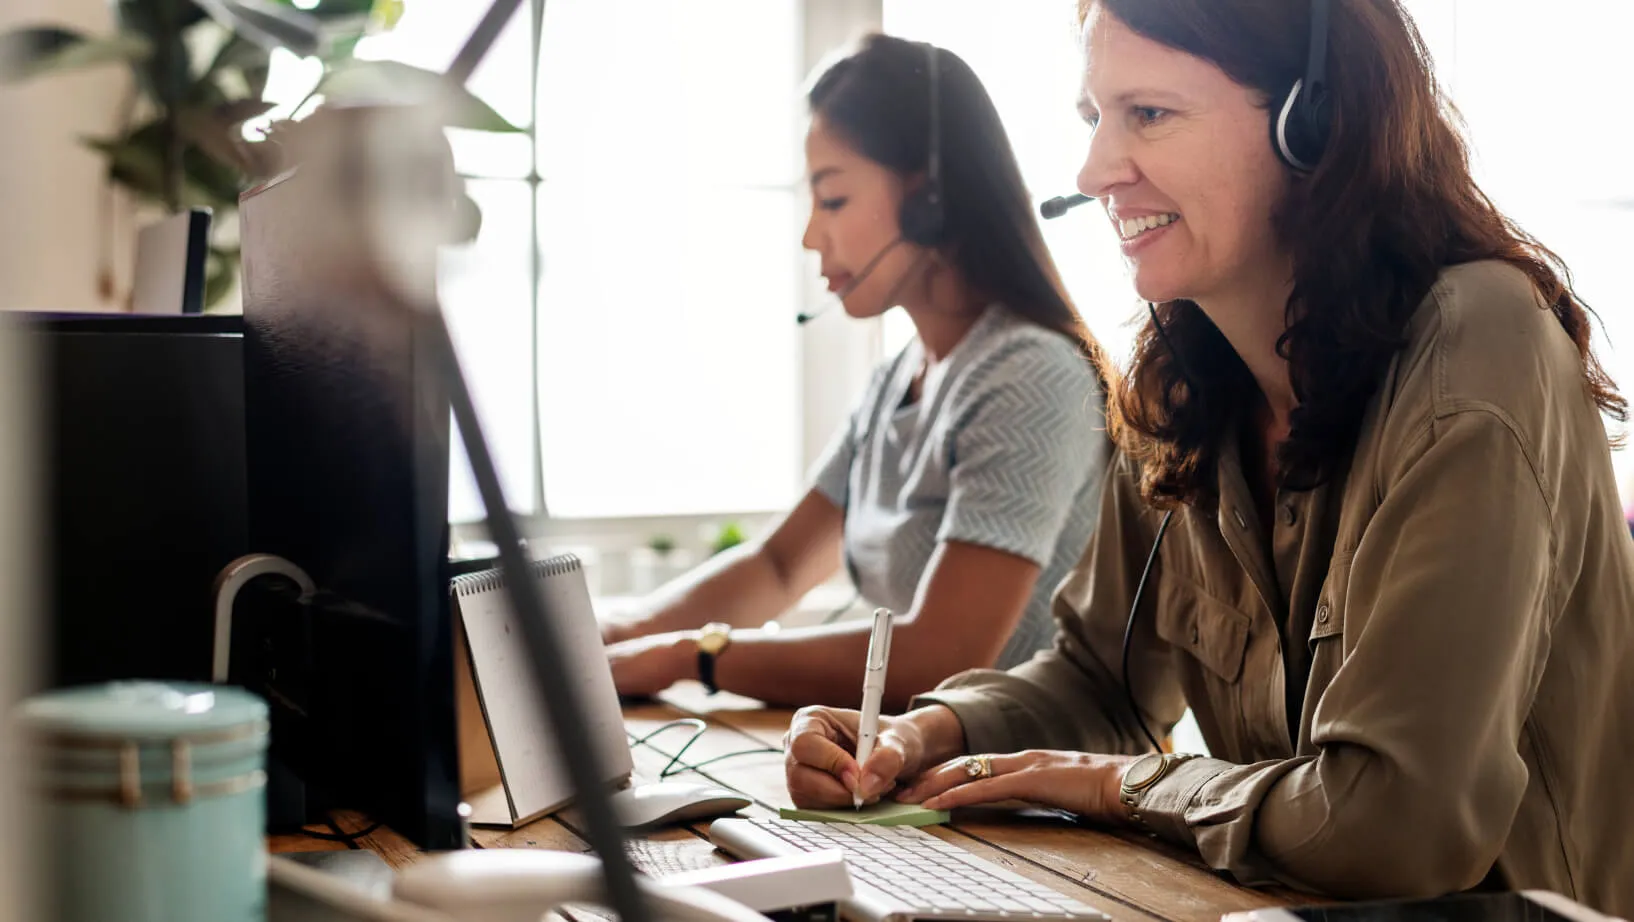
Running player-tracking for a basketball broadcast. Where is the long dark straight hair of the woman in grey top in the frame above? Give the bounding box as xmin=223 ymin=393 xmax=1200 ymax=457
xmin=806 ymin=34 xmax=1106 ymax=377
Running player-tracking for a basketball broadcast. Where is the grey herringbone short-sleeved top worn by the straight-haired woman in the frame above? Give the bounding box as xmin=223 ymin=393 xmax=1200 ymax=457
xmin=814 ymin=306 xmax=1109 ymax=669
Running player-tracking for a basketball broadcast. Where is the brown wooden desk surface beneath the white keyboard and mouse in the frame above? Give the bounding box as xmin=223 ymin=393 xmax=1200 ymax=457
xmin=268 ymin=685 xmax=1301 ymax=922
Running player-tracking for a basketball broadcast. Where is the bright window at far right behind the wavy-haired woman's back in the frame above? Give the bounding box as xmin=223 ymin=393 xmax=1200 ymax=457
xmin=1407 ymin=0 xmax=1634 ymax=487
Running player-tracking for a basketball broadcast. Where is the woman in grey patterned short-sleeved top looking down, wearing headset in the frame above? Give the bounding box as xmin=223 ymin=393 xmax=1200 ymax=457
xmin=603 ymin=36 xmax=1109 ymax=708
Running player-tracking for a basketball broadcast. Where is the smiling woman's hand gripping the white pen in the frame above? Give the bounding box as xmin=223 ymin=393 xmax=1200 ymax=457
xmin=783 ymin=706 xmax=964 ymax=809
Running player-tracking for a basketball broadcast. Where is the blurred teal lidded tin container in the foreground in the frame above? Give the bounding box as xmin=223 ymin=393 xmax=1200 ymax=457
xmin=20 ymin=682 xmax=266 ymax=922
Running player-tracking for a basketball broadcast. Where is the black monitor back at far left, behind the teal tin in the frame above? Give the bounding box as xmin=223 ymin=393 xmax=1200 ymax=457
xmin=10 ymin=314 xmax=248 ymax=685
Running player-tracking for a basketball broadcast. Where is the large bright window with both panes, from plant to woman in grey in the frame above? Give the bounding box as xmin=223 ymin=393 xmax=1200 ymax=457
xmin=273 ymin=0 xmax=810 ymax=521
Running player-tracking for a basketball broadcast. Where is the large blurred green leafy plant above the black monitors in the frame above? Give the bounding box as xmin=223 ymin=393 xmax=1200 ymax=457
xmin=0 ymin=0 xmax=521 ymax=306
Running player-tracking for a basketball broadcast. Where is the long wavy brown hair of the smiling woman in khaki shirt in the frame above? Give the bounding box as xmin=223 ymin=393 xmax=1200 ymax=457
xmin=1078 ymin=0 xmax=1627 ymax=507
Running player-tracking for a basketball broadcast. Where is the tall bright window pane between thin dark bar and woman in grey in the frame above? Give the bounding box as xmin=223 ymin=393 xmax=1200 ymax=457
xmin=538 ymin=0 xmax=804 ymax=518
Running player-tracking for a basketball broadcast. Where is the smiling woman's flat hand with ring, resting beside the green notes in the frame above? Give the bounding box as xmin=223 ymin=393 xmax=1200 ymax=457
xmin=895 ymin=749 xmax=1137 ymax=822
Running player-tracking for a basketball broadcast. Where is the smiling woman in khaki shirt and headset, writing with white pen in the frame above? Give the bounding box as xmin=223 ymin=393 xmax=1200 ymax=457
xmin=788 ymin=0 xmax=1634 ymax=915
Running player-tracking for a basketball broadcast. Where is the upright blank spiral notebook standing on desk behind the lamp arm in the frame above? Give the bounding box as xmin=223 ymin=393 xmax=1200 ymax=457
xmin=449 ymin=554 xmax=634 ymax=827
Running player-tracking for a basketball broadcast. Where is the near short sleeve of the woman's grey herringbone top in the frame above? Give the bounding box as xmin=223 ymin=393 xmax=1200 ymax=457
xmin=936 ymin=333 xmax=1105 ymax=567
